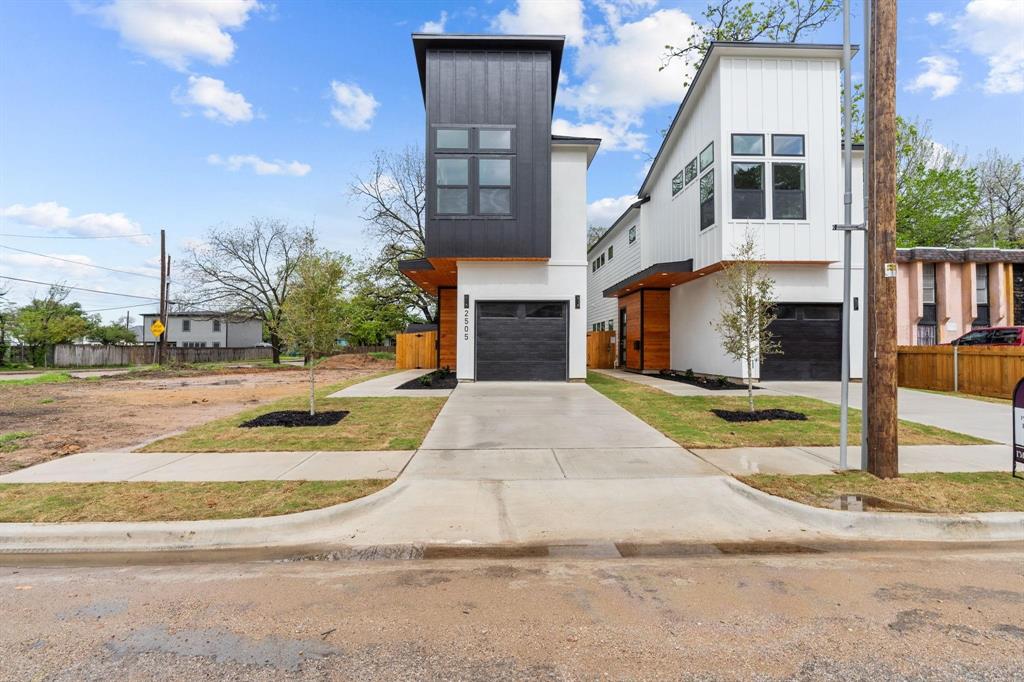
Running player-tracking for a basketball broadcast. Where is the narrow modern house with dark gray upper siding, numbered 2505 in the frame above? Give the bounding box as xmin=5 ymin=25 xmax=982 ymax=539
xmin=400 ymin=34 xmax=600 ymax=381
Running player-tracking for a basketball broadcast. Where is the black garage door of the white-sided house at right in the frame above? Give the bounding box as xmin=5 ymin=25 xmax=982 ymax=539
xmin=761 ymin=303 xmax=843 ymax=381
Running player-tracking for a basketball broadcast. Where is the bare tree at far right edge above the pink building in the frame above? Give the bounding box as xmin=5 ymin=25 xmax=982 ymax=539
xmin=977 ymin=150 xmax=1024 ymax=248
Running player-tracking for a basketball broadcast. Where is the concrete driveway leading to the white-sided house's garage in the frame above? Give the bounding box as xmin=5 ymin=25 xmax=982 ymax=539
xmin=759 ymin=381 xmax=1013 ymax=443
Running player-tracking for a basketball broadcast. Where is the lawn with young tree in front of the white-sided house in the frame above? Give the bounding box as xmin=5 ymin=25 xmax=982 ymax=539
xmin=587 ymin=372 xmax=987 ymax=447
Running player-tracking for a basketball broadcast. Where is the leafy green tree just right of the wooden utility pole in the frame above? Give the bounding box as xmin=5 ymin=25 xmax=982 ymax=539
xmin=896 ymin=117 xmax=979 ymax=247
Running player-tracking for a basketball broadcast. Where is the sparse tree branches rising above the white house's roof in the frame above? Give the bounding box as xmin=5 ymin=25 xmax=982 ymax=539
xmin=662 ymin=0 xmax=843 ymax=81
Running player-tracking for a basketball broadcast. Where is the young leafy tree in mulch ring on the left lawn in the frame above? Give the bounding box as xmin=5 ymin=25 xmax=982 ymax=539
xmin=280 ymin=250 xmax=347 ymax=415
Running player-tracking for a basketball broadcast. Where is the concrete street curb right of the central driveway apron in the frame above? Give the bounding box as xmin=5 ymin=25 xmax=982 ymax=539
xmin=727 ymin=476 xmax=1024 ymax=542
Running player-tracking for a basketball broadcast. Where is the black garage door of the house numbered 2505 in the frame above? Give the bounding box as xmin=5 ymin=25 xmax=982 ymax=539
xmin=476 ymin=301 xmax=568 ymax=381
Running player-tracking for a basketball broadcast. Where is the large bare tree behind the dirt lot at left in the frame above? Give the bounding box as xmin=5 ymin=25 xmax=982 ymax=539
xmin=176 ymin=218 xmax=315 ymax=363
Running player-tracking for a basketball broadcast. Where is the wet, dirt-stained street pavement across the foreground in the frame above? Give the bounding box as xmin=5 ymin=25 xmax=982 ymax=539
xmin=0 ymin=545 xmax=1024 ymax=681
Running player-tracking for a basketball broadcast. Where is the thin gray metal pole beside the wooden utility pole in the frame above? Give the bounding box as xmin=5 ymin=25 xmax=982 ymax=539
xmin=839 ymin=0 xmax=853 ymax=469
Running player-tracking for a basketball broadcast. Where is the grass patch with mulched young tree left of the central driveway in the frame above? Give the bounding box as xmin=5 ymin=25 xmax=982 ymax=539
xmin=140 ymin=372 xmax=446 ymax=453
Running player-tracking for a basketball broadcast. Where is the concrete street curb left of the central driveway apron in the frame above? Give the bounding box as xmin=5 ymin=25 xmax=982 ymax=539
xmin=0 ymin=480 xmax=406 ymax=555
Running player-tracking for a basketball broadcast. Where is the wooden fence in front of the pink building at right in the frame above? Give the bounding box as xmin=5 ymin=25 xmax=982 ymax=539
xmin=896 ymin=346 xmax=1024 ymax=398
